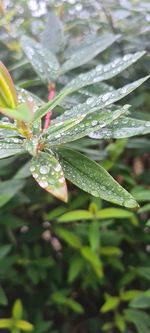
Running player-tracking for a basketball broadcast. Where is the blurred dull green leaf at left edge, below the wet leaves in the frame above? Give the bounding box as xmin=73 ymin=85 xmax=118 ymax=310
xmin=0 ymin=179 xmax=25 ymax=207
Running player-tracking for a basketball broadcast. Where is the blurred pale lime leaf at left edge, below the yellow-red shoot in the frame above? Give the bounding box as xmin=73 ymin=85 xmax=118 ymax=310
xmin=0 ymin=103 xmax=32 ymax=122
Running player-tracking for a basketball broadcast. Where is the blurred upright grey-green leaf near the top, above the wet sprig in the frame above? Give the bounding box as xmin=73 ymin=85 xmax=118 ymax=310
xmin=41 ymin=11 xmax=64 ymax=53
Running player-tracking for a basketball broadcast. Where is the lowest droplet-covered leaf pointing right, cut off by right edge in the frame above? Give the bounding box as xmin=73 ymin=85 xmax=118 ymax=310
xmin=89 ymin=117 xmax=150 ymax=139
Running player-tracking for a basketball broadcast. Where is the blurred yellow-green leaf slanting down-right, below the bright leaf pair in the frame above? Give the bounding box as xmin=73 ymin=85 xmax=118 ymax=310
xmin=80 ymin=246 xmax=103 ymax=278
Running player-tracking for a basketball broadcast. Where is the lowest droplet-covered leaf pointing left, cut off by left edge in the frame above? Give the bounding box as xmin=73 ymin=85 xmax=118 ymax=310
xmin=0 ymin=137 xmax=24 ymax=159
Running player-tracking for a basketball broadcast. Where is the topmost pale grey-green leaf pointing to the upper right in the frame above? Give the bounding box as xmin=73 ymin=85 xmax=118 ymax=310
xmin=61 ymin=34 xmax=120 ymax=73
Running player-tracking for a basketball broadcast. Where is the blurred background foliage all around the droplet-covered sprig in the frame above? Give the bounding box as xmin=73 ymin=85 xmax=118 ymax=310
xmin=0 ymin=1 xmax=150 ymax=333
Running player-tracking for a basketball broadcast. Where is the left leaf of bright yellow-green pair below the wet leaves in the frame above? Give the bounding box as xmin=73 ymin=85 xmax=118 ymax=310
xmin=57 ymin=209 xmax=93 ymax=222
